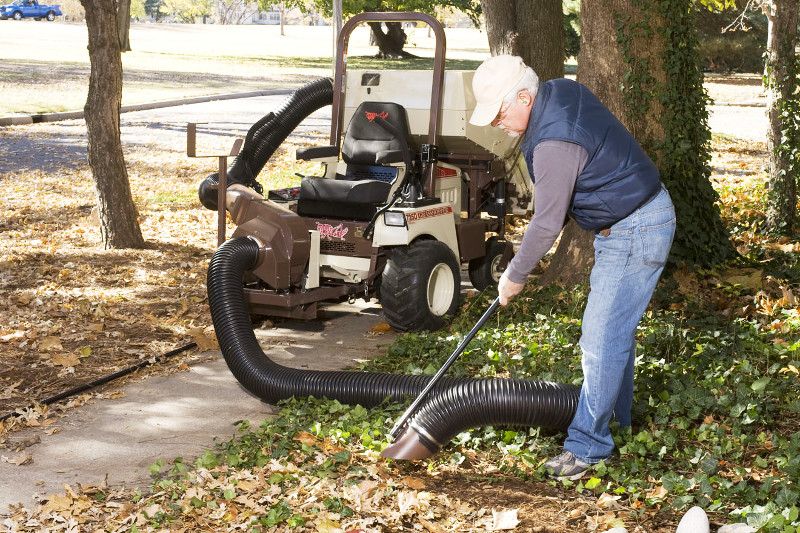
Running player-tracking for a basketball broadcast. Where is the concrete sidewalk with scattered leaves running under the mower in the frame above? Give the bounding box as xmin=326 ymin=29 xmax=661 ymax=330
xmin=0 ymin=300 xmax=396 ymax=516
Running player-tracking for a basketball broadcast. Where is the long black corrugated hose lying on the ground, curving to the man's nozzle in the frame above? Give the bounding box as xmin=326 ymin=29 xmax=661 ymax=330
xmin=207 ymin=237 xmax=579 ymax=458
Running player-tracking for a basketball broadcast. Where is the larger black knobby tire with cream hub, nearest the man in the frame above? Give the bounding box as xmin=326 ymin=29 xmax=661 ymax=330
xmin=380 ymin=241 xmax=461 ymax=331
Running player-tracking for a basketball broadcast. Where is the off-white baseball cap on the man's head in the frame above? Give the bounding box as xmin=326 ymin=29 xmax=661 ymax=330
xmin=469 ymin=55 xmax=525 ymax=126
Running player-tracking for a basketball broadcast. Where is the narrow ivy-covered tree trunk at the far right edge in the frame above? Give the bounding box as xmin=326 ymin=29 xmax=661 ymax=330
xmin=765 ymin=0 xmax=798 ymax=235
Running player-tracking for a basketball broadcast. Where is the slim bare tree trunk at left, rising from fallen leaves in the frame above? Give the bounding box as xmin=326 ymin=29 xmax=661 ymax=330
xmin=81 ymin=0 xmax=144 ymax=249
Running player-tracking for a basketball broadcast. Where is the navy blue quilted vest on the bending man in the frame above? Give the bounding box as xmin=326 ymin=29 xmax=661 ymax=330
xmin=520 ymin=78 xmax=661 ymax=231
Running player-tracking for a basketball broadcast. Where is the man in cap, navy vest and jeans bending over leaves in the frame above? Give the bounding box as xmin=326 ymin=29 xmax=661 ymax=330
xmin=470 ymin=55 xmax=675 ymax=480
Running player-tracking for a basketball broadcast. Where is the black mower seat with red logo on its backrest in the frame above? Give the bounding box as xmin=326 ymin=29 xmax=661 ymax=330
xmin=297 ymin=102 xmax=410 ymax=220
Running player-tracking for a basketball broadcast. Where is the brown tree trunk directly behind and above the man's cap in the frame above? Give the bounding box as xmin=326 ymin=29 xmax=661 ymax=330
xmin=481 ymin=0 xmax=564 ymax=81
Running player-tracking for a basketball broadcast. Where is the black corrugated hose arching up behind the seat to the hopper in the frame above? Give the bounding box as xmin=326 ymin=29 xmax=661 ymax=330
xmin=203 ymin=78 xmax=333 ymax=210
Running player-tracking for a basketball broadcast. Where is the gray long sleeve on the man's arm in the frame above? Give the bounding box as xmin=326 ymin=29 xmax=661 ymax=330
xmin=506 ymin=141 xmax=589 ymax=283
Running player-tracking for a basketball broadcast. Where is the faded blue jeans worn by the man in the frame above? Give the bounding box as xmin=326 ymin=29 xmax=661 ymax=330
xmin=564 ymin=186 xmax=675 ymax=463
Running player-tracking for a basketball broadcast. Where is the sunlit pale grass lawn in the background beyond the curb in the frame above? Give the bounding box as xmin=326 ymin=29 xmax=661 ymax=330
xmin=0 ymin=21 xmax=489 ymax=116
